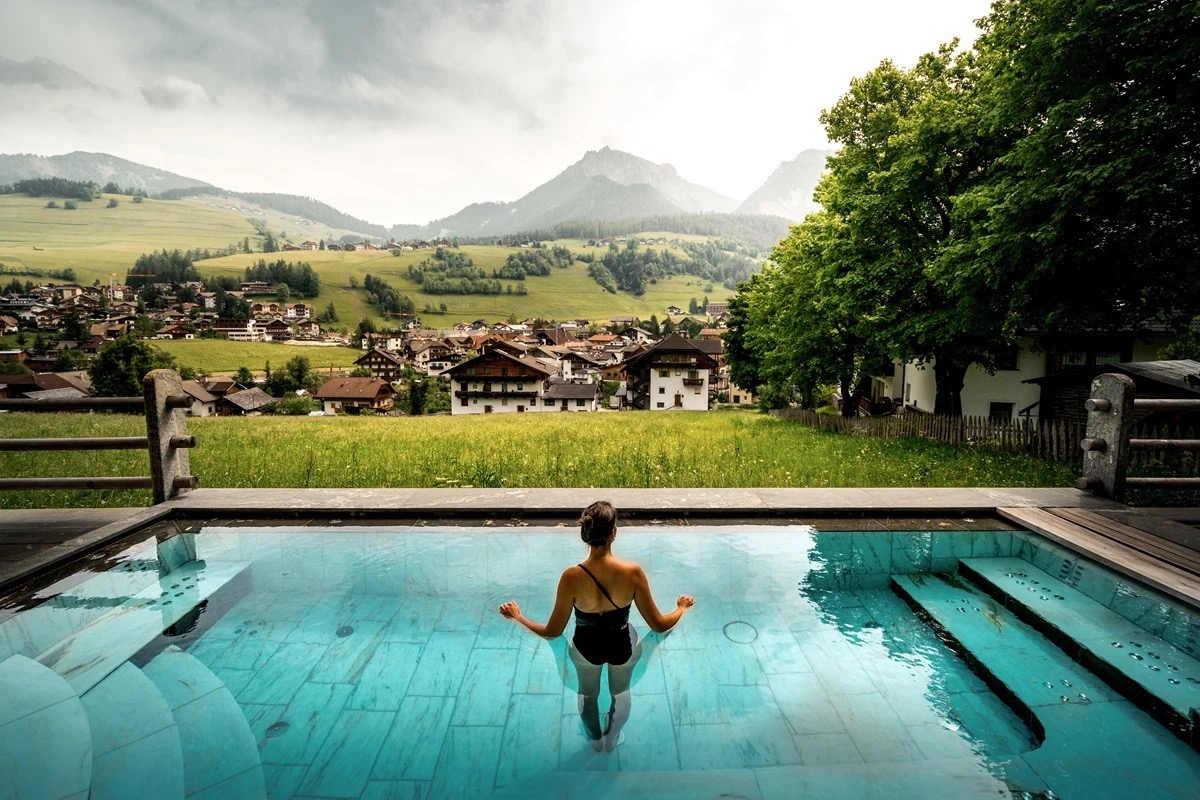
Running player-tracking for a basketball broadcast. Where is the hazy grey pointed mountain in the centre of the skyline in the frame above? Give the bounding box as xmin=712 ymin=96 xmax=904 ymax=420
xmin=428 ymin=148 xmax=737 ymax=236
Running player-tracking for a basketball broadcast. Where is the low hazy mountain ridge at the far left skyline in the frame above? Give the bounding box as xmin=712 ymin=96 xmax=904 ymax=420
xmin=0 ymin=150 xmax=210 ymax=194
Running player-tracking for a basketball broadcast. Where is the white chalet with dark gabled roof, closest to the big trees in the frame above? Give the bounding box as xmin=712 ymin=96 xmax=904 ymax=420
xmin=625 ymin=333 xmax=719 ymax=411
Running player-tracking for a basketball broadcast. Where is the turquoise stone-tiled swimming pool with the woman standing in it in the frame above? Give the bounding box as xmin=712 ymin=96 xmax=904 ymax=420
xmin=0 ymin=524 xmax=1200 ymax=799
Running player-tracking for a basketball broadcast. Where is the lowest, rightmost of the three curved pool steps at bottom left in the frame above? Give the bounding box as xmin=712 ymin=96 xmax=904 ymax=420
xmin=142 ymin=645 xmax=266 ymax=800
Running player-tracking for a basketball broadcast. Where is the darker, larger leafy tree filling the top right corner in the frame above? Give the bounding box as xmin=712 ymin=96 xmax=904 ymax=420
xmin=942 ymin=0 xmax=1200 ymax=348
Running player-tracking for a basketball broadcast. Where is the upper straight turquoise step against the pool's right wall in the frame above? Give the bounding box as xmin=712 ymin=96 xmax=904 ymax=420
xmin=959 ymin=558 xmax=1200 ymax=747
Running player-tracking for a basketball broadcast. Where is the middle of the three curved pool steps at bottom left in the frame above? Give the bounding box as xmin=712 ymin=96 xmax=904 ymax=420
xmin=80 ymin=663 xmax=184 ymax=800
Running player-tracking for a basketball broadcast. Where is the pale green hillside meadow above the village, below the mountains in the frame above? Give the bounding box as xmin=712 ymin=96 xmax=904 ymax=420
xmin=0 ymin=194 xmax=732 ymax=329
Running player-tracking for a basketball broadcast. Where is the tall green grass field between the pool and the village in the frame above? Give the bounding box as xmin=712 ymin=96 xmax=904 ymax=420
xmin=0 ymin=411 xmax=1075 ymax=509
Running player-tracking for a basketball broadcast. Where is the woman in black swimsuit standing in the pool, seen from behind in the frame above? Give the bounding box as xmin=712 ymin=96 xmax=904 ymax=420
xmin=500 ymin=500 xmax=696 ymax=752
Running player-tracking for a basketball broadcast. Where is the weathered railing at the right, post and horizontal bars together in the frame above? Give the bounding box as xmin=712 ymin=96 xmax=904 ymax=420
xmin=1078 ymin=373 xmax=1200 ymax=503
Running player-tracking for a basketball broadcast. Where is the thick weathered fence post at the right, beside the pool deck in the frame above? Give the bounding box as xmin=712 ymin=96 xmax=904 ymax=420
xmin=1079 ymin=373 xmax=1134 ymax=503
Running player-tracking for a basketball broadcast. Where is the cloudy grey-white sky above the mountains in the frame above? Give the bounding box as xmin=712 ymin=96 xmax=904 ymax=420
xmin=0 ymin=0 xmax=988 ymax=224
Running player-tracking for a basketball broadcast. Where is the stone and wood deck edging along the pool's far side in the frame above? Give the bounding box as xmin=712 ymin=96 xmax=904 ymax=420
xmin=0 ymin=488 xmax=1200 ymax=607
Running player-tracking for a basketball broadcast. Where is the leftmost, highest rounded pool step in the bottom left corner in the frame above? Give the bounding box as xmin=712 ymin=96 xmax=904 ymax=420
xmin=0 ymin=655 xmax=92 ymax=800
